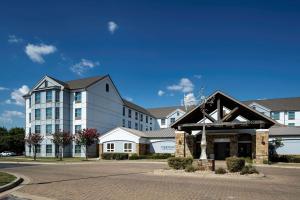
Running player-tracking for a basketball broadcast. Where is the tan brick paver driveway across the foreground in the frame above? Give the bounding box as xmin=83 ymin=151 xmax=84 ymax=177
xmin=0 ymin=161 xmax=300 ymax=200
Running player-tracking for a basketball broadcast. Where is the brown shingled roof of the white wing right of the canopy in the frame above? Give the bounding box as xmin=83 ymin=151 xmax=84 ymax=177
xmin=242 ymin=97 xmax=300 ymax=111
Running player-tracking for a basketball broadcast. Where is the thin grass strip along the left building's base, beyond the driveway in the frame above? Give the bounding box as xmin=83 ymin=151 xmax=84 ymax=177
xmin=0 ymin=156 xmax=95 ymax=162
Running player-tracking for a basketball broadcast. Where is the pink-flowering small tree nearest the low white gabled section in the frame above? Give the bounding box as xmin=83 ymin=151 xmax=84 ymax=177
xmin=75 ymin=128 xmax=100 ymax=160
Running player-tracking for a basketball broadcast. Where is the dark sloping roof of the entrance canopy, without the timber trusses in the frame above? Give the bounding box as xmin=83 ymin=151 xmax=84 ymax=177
xmin=171 ymin=91 xmax=277 ymax=128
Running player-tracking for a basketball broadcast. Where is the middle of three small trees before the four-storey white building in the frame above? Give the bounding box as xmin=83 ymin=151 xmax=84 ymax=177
xmin=52 ymin=132 xmax=73 ymax=160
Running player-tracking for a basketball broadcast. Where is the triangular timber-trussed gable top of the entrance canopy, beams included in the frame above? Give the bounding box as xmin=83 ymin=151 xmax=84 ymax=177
xmin=171 ymin=91 xmax=277 ymax=132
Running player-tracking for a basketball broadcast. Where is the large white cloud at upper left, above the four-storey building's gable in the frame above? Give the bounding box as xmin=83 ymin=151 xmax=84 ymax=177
xmin=25 ymin=44 xmax=57 ymax=64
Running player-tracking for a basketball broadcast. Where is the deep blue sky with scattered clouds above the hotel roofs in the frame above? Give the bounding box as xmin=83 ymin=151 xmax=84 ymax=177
xmin=0 ymin=0 xmax=300 ymax=127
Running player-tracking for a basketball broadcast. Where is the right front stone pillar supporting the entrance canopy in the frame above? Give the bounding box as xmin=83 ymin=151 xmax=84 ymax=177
xmin=255 ymin=129 xmax=269 ymax=164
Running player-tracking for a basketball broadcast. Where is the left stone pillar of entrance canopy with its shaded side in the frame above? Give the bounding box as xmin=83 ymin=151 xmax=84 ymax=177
xmin=175 ymin=131 xmax=194 ymax=157
